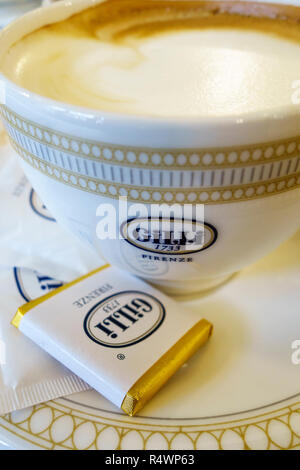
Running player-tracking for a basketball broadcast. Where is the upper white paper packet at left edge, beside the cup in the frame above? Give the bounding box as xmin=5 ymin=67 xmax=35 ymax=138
xmin=0 ymin=142 xmax=103 ymax=281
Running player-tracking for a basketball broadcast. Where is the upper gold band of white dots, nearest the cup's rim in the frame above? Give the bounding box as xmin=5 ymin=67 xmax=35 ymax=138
xmin=0 ymin=105 xmax=300 ymax=170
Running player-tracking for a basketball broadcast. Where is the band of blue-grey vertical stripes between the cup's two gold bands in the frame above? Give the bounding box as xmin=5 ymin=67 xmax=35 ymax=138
xmin=8 ymin=138 xmax=300 ymax=189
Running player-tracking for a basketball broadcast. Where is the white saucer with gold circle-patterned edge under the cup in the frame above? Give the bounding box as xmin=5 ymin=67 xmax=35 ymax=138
xmin=0 ymin=226 xmax=300 ymax=449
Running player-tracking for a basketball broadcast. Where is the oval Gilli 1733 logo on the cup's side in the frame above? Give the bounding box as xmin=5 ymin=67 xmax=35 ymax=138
xmin=121 ymin=217 xmax=218 ymax=255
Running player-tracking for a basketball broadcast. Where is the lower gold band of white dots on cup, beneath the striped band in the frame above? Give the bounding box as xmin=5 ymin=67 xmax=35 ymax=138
xmin=11 ymin=141 xmax=300 ymax=204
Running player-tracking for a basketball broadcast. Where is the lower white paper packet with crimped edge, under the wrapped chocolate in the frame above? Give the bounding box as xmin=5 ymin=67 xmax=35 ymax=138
xmin=0 ymin=268 xmax=89 ymax=415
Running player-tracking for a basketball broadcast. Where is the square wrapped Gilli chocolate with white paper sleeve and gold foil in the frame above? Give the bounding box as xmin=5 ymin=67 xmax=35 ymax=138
xmin=12 ymin=265 xmax=212 ymax=416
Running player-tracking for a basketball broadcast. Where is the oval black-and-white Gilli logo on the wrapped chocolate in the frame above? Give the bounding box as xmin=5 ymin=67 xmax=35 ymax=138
xmin=84 ymin=291 xmax=166 ymax=348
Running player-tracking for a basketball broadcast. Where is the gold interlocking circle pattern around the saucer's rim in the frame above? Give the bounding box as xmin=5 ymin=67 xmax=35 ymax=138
xmin=0 ymin=400 xmax=300 ymax=450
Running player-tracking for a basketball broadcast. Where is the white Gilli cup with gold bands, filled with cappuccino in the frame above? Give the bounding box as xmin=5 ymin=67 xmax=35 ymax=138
xmin=0 ymin=0 xmax=300 ymax=294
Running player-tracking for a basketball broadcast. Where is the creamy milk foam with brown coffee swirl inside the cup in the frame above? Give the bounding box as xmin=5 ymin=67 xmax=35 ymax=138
xmin=0 ymin=0 xmax=300 ymax=116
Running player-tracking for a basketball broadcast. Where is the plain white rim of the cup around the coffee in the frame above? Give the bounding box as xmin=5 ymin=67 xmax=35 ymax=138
xmin=0 ymin=0 xmax=300 ymax=127
